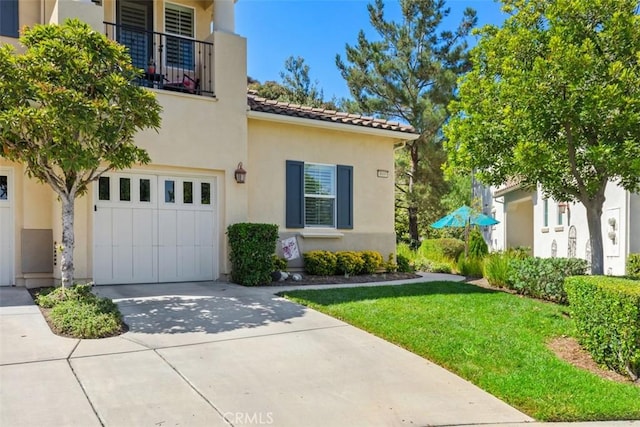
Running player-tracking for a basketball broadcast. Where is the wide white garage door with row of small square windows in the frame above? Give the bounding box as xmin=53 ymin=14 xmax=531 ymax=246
xmin=93 ymin=173 xmax=217 ymax=284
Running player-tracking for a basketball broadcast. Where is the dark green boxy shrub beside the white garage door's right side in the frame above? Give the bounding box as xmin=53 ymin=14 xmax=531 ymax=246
xmin=227 ymin=222 xmax=278 ymax=286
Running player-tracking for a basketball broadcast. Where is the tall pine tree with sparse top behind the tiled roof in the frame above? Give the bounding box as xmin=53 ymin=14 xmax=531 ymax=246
xmin=336 ymin=0 xmax=476 ymax=241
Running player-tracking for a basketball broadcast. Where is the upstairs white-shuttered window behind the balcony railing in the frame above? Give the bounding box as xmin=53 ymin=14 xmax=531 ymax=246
xmin=164 ymin=3 xmax=195 ymax=70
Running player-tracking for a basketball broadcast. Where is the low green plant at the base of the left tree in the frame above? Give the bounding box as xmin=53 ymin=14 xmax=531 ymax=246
xmin=31 ymin=284 xmax=127 ymax=338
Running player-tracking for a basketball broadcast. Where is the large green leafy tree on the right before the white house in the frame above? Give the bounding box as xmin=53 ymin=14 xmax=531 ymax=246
xmin=445 ymin=0 xmax=640 ymax=274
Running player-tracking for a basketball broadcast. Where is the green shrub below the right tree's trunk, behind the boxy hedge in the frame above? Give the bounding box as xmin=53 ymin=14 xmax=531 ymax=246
xmin=511 ymin=257 xmax=587 ymax=304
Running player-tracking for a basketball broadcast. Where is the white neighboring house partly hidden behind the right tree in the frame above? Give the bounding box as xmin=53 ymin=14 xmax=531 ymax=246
xmin=476 ymin=182 xmax=640 ymax=275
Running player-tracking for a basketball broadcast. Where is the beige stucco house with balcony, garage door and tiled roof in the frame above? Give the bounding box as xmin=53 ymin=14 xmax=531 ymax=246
xmin=0 ymin=0 xmax=417 ymax=287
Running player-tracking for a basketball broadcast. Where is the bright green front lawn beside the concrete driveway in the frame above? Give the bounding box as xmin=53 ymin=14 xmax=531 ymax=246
xmin=283 ymin=282 xmax=640 ymax=421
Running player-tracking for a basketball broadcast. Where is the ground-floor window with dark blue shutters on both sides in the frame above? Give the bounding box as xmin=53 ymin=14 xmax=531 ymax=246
xmin=285 ymin=160 xmax=353 ymax=229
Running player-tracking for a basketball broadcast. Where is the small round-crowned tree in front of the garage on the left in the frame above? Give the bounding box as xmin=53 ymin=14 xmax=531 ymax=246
xmin=0 ymin=20 xmax=161 ymax=286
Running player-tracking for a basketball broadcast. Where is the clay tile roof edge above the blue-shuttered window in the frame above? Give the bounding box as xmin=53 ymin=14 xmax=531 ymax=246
xmin=247 ymin=91 xmax=416 ymax=134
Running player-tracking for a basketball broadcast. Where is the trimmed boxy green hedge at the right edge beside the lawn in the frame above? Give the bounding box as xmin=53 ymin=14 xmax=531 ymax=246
xmin=565 ymin=276 xmax=640 ymax=380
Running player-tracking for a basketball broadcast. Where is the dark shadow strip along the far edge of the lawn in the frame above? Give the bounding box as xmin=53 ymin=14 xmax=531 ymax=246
xmin=278 ymin=282 xmax=503 ymax=305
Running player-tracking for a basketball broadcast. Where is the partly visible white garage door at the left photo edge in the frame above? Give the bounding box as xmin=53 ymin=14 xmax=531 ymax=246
xmin=0 ymin=168 xmax=13 ymax=286
